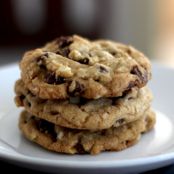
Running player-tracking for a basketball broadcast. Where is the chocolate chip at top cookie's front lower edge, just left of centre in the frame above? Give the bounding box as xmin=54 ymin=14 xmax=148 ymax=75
xmin=68 ymin=81 xmax=85 ymax=96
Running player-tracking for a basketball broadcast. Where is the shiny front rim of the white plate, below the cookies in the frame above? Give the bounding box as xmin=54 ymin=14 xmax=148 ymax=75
xmin=0 ymin=147 xmax=174 ymax=169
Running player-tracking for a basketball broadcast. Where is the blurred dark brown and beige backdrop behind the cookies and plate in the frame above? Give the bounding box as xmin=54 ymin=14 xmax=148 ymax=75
xmin=0 ymin=0 xmax=174 ymax=67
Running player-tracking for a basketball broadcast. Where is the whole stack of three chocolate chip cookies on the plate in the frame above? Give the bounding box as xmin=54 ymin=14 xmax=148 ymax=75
xmin=15 ymin=35 xmax=155 ymax=154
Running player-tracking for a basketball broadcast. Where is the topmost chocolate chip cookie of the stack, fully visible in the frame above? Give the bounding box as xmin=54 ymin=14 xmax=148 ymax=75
xmin=20 ymin=35 xmax=151 ymax=99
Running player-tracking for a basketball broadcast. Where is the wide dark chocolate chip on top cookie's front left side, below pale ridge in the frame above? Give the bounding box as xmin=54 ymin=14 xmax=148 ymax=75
xmin=45 ymin=72 xmax=65 ymax=85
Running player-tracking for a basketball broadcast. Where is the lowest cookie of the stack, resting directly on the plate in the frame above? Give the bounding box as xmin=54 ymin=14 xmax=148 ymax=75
xmin=19 ymin=110 xmax=155 ymax=154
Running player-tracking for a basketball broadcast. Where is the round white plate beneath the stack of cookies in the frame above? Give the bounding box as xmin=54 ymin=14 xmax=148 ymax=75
xmin=0 ymin=64 xmax=174 ymax=173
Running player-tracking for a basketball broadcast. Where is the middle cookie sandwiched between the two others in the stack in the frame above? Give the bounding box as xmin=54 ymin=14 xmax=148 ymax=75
xmin=15 ymin=80 xmax=152 ymax=130
